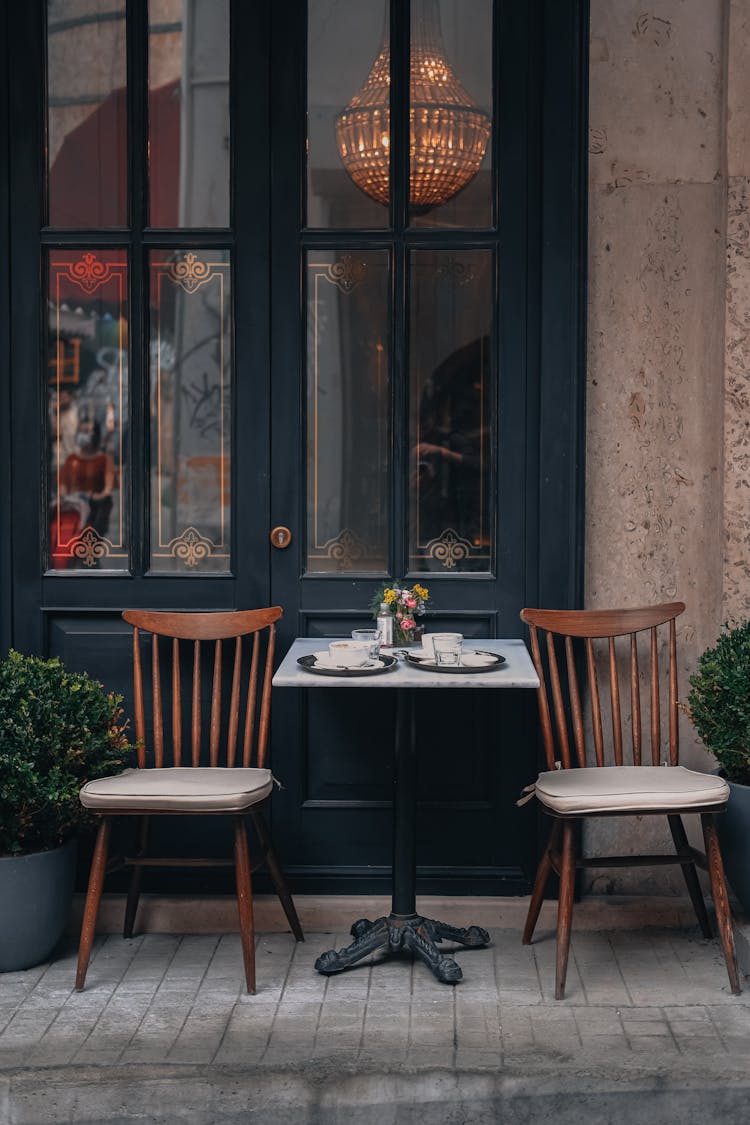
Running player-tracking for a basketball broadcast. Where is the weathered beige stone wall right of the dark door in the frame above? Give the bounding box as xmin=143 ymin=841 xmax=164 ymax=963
xmin=586 ymin=0 xmax=750 ymax=892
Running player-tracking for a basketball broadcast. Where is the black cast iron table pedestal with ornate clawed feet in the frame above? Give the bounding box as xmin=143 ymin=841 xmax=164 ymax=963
xmin=315 ymin=687 xmax=489 ymax=984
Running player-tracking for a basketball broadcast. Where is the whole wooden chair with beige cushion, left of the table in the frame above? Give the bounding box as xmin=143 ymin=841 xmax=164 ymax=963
xmin=75 ymin=606 xmax=304 ymax=992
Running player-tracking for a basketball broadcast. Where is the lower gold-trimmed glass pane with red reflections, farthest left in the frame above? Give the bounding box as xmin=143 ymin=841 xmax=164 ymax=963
xmin=46 ymin=249 xmax=128 ymax=574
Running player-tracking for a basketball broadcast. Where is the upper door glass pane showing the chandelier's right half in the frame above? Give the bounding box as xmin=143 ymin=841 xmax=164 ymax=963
xmin=409 ymin=0 xmax=493 ymax=227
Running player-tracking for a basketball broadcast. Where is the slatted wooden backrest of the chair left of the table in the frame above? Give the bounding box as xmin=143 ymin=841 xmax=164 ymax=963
xmin=123 ymin=605 xmax=282 ymax=768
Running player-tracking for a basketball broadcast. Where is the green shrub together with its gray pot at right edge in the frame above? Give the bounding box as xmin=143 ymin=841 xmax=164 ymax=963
xmin=686 ymin=621 xmax=750 ymax=915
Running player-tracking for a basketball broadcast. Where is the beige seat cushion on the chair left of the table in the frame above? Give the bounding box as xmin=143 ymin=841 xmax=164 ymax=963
xmin=80 ymin=766 xmax=273 ymax=812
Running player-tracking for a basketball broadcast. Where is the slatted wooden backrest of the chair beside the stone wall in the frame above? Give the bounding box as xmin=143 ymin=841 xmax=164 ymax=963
xmin=521 ymin=602 xmax=685 ymax=770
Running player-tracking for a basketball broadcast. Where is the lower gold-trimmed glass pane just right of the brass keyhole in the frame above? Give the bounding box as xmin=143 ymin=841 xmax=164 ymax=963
xmin=306 ymin=250 xmax=390 ymax=574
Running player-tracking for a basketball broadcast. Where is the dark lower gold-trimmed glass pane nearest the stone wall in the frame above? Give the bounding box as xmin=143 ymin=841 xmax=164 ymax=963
xmin=409 ymin=250 xmax=495 ymax=574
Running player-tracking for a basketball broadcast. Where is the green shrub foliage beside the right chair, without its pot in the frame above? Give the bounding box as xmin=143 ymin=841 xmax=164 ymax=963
xmin=687 ymin=621 xmax=750 ymax=785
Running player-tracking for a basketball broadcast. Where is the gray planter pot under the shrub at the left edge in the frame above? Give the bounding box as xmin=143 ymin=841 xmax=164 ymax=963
xmin=0 ymin=839 xmax=76 ymax=973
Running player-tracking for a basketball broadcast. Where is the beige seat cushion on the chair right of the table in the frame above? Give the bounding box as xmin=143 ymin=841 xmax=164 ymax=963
xmin=536 ymin=766 xmax=729 ymax=816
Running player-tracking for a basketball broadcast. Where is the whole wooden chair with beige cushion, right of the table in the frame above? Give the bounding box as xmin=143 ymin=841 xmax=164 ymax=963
xmin=521 ymin=602 xmax=740 ymax=1000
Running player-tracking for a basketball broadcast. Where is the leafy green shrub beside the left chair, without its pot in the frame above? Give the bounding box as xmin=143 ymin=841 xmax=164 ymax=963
xmin=0 ymin=651 xmax=130 ymax=855
